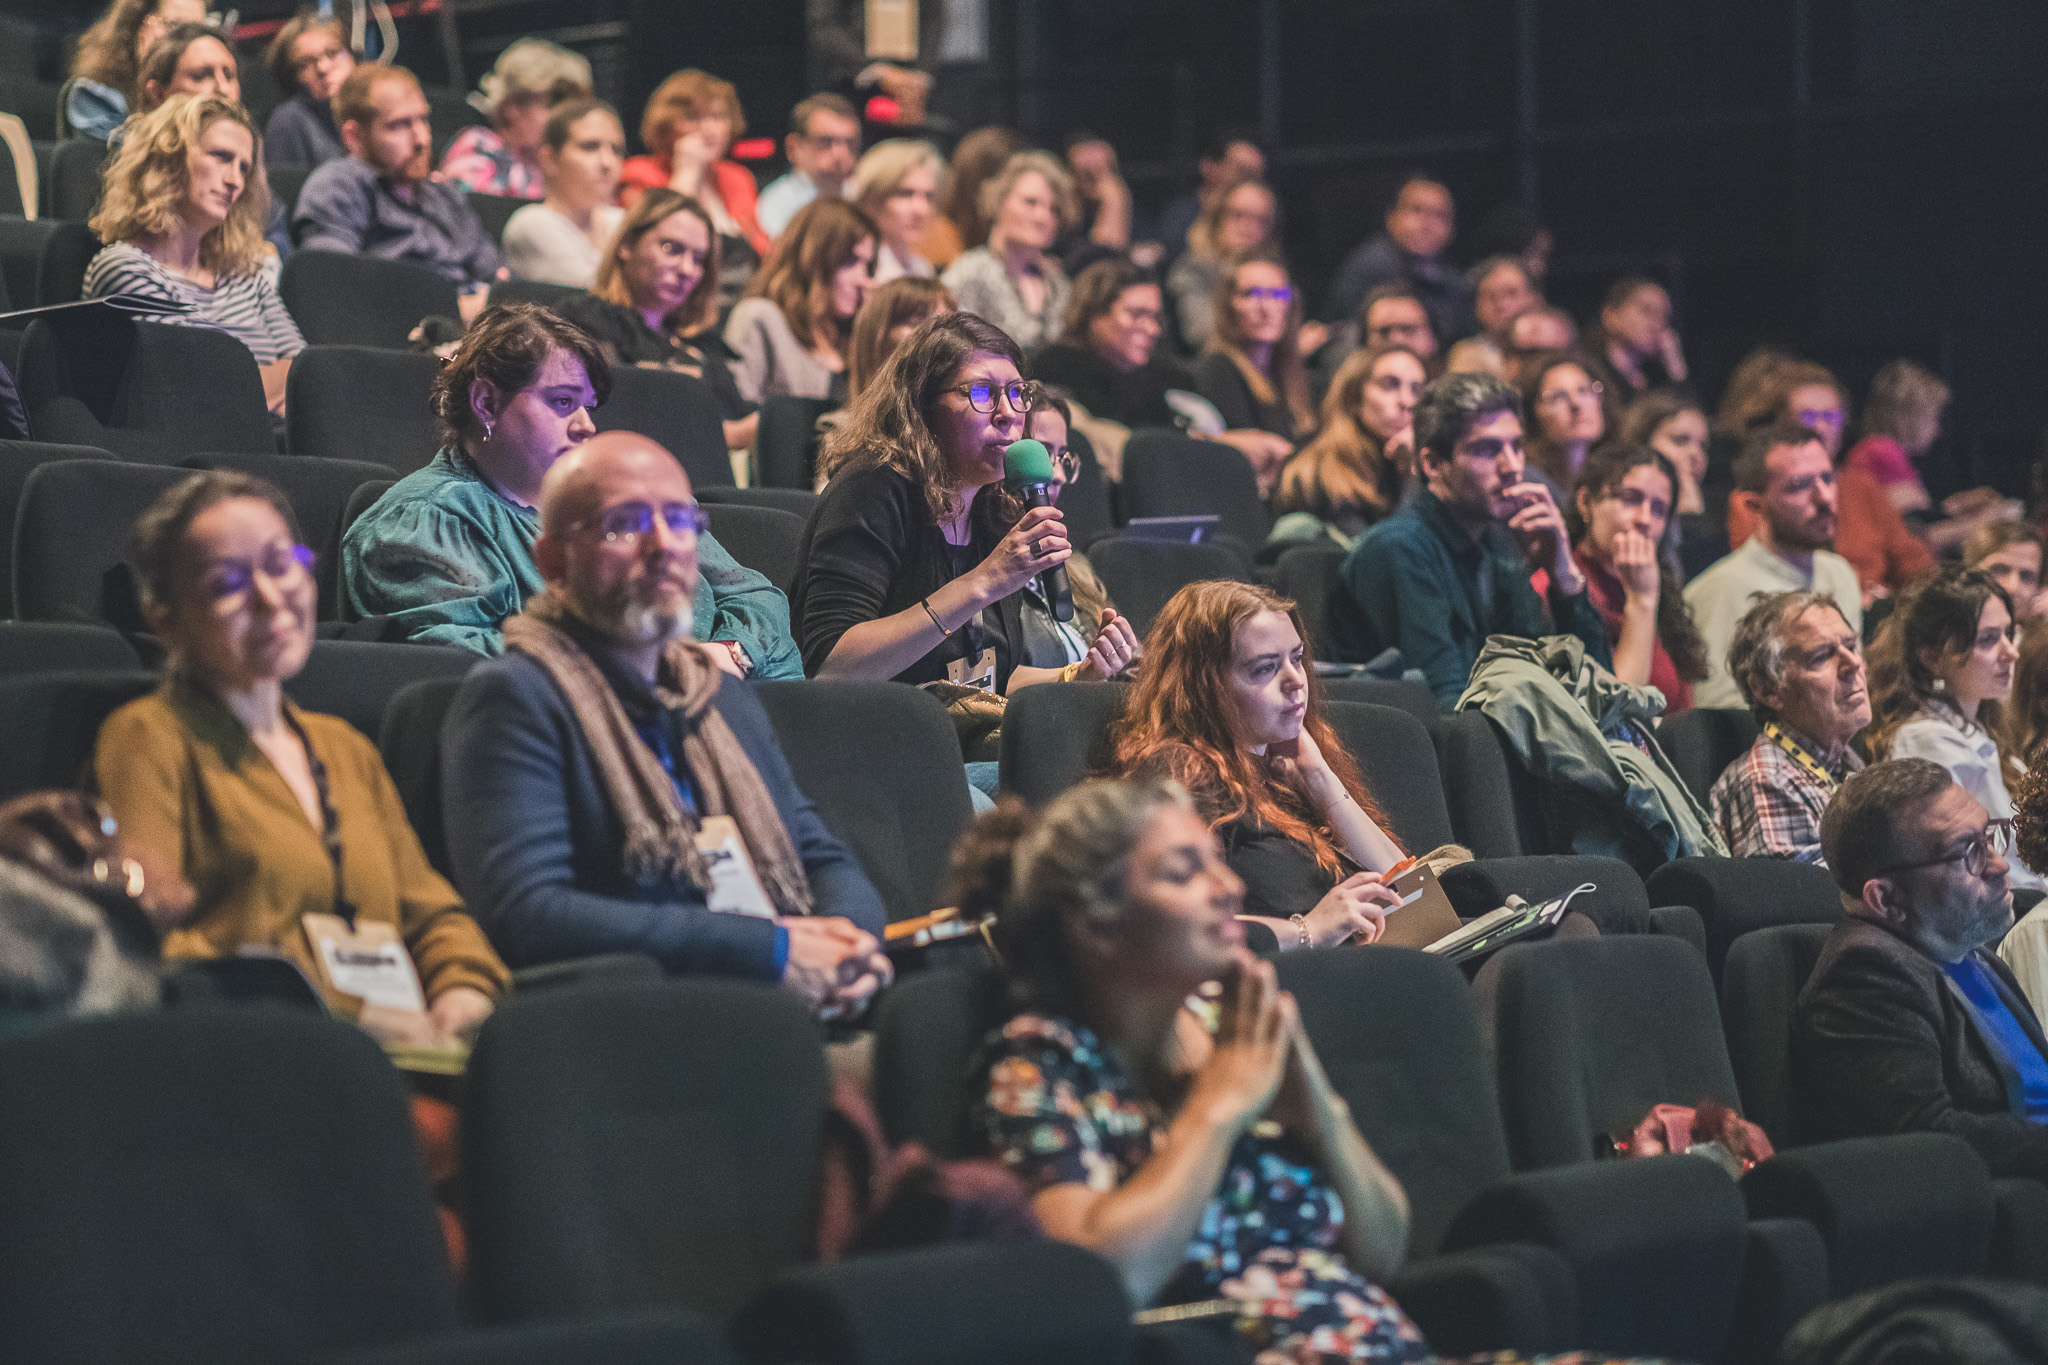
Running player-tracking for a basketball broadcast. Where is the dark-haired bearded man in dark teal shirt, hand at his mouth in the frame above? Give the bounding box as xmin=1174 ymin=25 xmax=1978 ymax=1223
xmin=1329 ymin=375 xmax=1612 ymax=706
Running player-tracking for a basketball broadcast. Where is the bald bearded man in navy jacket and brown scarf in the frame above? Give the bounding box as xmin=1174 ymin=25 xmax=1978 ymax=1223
xmin=444 ymin=432 xmax=891 ymax=1017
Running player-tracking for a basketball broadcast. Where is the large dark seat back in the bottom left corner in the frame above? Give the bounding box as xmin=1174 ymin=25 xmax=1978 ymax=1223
xmin=0 ymin=1005 xmax=461 ymax=1365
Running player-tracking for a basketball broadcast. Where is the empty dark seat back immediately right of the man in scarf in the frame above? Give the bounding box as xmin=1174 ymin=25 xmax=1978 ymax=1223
xmin=756 ymin=681 xmax=973 ymax=921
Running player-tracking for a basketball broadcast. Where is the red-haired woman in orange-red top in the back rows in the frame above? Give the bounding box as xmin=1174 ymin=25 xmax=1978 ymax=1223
xmin=618 ymin=70 xmax=768 ymax=263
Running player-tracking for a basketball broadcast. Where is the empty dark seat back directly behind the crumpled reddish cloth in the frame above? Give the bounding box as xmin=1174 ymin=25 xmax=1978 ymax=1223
xmin=1493 ymin=935 xmax=1741 ymax=1171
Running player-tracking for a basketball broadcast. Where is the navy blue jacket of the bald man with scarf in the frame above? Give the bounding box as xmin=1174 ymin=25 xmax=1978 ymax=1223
xmin=442 ymin=651 xmax=887 ymax=980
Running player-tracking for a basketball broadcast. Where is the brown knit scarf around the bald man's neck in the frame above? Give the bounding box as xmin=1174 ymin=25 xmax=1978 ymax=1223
xmin=506 ymin=591 xmax=811 ymax=915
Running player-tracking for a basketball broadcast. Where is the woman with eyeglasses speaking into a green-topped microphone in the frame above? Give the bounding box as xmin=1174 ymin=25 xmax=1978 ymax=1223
xmin=791 ymin=313 xmax=1137 ymax=694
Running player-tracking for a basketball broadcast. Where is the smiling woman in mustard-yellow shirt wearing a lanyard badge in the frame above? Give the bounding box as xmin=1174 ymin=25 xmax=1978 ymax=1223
xmin=92 ymin=471 xmax=510 ymax=1046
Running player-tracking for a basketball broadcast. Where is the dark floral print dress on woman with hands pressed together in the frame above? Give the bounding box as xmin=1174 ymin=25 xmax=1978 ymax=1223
xmin=971 ymin=1013 xmax=1432 ymax=1361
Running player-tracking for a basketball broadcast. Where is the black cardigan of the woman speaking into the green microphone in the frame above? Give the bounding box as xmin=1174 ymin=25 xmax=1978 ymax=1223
xmin=788 ymin=465 xmax=1026 ymax=692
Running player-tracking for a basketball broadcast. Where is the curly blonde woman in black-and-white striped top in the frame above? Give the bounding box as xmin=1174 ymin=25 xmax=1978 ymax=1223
xmin=86 ymin=94 xmax=305 ymax=411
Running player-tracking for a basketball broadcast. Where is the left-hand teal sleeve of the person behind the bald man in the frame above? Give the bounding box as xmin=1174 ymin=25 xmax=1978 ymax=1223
xmin=342 ymin=499 xmax=543 ymax=657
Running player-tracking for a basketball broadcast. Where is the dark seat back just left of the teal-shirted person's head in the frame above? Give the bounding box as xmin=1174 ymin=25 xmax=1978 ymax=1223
xmin=285 ymin=346 xmax=440 ymax=475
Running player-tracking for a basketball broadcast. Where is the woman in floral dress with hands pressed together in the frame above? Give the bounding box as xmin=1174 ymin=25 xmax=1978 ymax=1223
xmin=956 ymin=782 xmax=1430 ymax=1361
